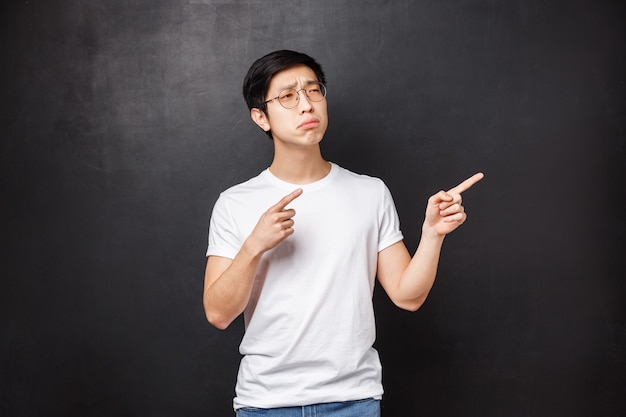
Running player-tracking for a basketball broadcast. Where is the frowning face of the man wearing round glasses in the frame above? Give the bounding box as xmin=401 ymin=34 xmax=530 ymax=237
xmin=251 ymin=65 xmax=328 ymax=146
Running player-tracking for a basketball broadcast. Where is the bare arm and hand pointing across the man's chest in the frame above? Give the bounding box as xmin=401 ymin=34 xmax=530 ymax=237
xmin=202 ymin=189 xmax=302 ymax=329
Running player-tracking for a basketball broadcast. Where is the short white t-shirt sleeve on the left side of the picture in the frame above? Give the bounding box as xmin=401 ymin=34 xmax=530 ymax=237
xmin=206 ymin=195 xmax=242 ymax=259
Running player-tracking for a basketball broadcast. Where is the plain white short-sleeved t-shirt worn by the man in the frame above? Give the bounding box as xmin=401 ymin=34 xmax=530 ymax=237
xmin=207 ymin=164 xmax=402 ymax=409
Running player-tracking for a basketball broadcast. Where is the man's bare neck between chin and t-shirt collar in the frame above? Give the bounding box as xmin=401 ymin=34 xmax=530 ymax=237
xmin=270 ymin=146 xmax=330 ymax=184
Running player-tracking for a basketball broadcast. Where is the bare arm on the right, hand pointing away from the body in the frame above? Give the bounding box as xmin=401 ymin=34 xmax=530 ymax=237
xmin=377 ymin=173 xmax=484 ymax=311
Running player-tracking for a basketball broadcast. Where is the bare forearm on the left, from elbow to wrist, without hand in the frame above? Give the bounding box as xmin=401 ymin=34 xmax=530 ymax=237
xmin=203 ymin=240 xmax=262 ymax=329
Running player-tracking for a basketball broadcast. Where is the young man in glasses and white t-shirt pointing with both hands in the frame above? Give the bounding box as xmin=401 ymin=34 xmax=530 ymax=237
xmin=203 ymin=51 xmax=482 ymax=417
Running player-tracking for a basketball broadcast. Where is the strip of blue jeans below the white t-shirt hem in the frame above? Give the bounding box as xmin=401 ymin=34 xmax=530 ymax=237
xmin=237 ymin=398 xmax=380 ymax=417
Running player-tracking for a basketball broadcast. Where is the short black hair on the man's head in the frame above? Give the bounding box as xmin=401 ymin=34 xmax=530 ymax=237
xmin=243 ymin=49 xmax=326 ymax=138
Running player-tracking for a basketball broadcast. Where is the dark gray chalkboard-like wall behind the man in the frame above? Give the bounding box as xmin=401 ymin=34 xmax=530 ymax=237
xmin=0 ymin=0 xmax=626 ymax=417
